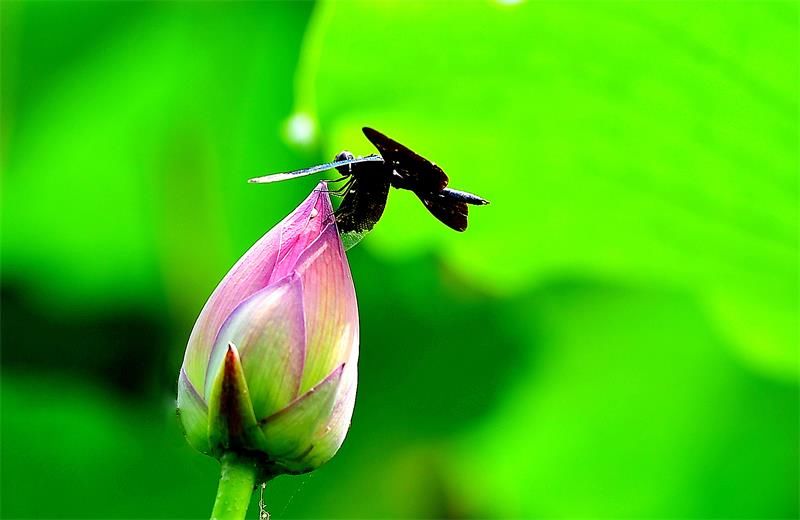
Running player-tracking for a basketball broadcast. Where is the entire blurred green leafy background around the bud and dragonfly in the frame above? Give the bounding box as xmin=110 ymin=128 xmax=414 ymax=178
xmin=0 ymin=1 xmax=800 ymax=519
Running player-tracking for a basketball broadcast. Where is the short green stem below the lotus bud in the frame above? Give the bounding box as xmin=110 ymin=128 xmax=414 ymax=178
xmin=211 ymin=452 xmax=258 ymax=520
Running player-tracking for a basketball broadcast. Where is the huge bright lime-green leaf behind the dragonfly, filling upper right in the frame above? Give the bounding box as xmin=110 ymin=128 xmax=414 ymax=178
xmin=297 ymin=1 xmax=800 ymax=377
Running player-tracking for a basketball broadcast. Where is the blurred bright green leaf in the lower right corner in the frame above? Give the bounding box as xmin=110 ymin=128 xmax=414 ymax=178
xmin=452 ymin=284 xmax=800 ymax=519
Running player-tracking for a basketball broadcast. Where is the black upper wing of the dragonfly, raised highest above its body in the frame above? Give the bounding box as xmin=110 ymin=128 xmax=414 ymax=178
xmin=362 ymin=127 xmax=448 ymax=192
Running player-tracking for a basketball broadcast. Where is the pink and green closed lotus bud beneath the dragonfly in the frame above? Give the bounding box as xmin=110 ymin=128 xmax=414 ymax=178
xmin=178 ymin=183 xmax=358 ymax=476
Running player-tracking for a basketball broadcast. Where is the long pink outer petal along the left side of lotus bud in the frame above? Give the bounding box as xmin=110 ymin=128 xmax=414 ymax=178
xmin=183 ymin=183 xmax=333 ymax=394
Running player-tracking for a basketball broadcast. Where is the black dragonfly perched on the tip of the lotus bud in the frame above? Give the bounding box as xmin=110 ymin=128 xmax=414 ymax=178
xmin=248 ymin=127 xmax=489 ymax=234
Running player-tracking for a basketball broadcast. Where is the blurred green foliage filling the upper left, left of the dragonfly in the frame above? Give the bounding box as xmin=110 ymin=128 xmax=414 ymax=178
xmin=2 ymin=2 xmax=311 ymax=316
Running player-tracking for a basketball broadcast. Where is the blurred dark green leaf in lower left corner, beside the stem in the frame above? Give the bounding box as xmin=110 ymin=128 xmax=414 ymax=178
xmin=0 ymin=373 xmax=217 ymax=518
